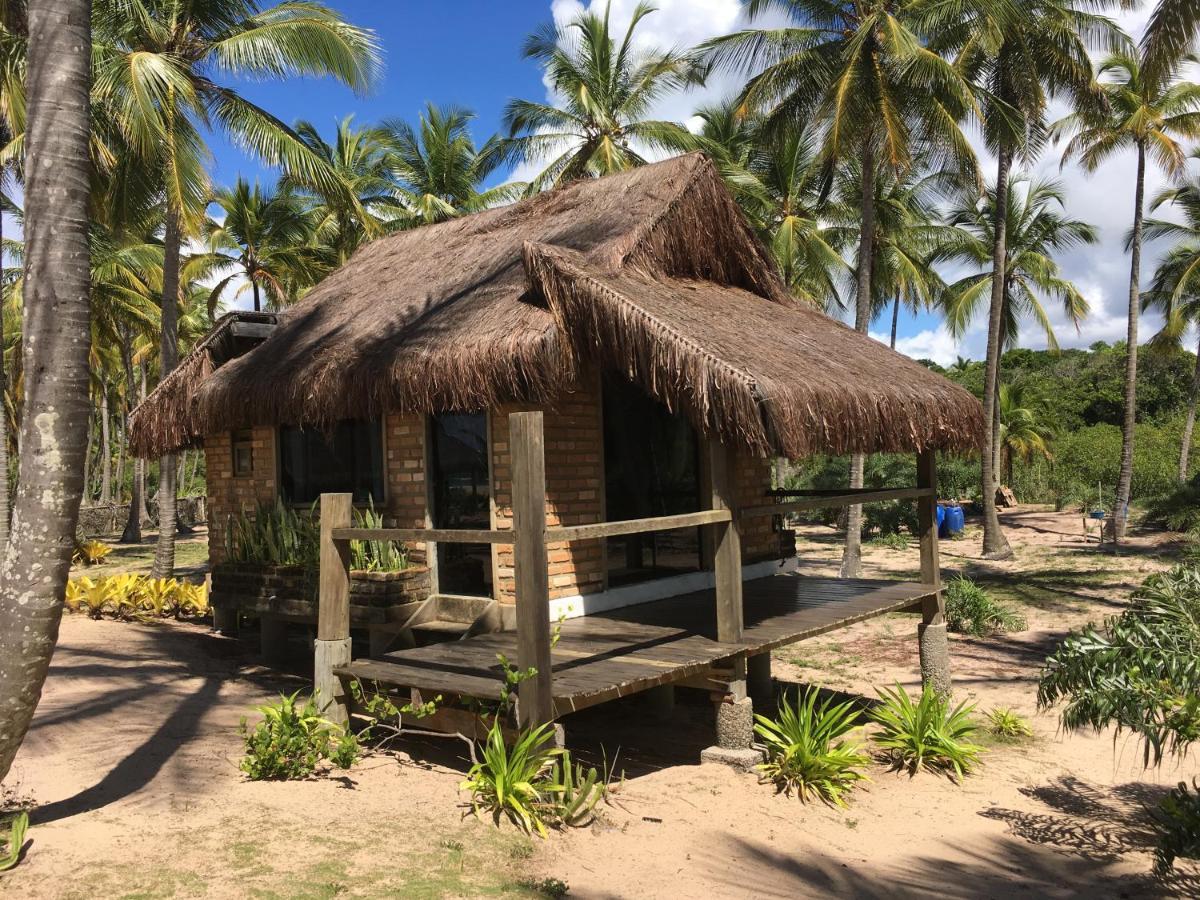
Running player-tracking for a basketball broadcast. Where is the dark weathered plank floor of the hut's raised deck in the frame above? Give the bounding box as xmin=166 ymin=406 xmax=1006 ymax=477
xmin=335 ymin=575 xmax=930 ymax=715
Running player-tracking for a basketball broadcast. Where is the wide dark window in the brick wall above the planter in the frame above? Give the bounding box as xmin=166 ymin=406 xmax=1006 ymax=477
xmin=280 ymin=421 xmax=384 ymax=505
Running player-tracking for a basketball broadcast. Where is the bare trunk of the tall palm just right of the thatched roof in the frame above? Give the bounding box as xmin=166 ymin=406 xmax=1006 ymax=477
xmin=979 ymin=144 xmax=1013 ymax=559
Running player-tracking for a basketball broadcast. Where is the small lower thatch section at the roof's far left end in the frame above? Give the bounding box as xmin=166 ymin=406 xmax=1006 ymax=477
xmin=130 ymin=311 xmax=276 ymax=457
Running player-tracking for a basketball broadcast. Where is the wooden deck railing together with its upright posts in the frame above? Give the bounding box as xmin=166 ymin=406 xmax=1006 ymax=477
xmin=313 ymin=412 xmax=942 ymax=725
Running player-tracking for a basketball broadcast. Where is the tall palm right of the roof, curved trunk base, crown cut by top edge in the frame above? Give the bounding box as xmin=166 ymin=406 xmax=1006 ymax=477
xmin=922 ymin=0 xmax=1128 ymax=559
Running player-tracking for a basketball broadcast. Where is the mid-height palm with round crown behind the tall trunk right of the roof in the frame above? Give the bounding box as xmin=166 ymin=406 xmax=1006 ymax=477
xmin=936 ymin=173 xmax=1098 ymax=481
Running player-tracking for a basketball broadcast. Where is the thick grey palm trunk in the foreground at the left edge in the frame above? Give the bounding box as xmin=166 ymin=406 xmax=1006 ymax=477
xmin=0 ymin=0 xmax=91 ymax=781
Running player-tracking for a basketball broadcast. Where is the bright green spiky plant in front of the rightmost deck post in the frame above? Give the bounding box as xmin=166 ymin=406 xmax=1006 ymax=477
xmin=870 ymin=684 xmax=983 ymax=779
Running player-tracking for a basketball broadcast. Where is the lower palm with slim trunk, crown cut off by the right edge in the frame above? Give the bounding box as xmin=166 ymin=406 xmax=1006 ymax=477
xmin=1142 ymin=165 xmax=1200 ymax=482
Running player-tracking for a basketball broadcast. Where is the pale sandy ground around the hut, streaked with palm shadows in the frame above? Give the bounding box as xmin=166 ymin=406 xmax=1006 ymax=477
xmin=0 ymin=510 xmax=1200 ymax=899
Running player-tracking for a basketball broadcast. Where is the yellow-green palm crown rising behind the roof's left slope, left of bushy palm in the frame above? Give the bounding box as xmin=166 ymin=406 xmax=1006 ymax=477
xmin=280 ymin=116 xmax=401 ymax=269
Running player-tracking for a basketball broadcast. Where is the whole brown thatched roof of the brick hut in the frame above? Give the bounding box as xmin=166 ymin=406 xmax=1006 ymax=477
xmin=131 ymin=155 xmax=983 ymax=457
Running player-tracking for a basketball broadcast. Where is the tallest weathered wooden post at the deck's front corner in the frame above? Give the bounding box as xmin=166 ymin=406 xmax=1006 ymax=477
xmin=509 ymin=412 xmax=554 ymax=727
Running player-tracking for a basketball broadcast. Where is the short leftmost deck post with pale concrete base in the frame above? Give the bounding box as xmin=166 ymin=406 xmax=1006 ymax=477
xmin=312 ymin=493 xmax=353 ymax=725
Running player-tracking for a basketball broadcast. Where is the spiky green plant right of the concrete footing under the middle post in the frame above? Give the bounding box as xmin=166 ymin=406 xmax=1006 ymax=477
xmin=754 ymin=688 xmax=870 ymax=806
